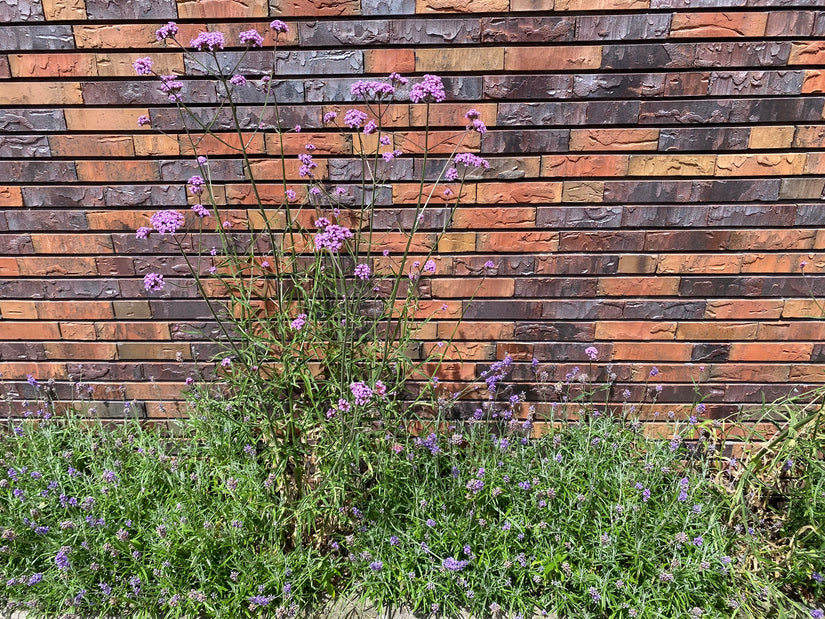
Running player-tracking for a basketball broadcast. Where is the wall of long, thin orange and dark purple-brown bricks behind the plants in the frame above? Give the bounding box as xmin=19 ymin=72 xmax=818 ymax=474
xmin=0 ymin=0 xmax=825 ymax=416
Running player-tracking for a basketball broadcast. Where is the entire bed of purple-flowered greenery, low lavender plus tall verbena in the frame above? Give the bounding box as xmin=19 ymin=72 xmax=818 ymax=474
xmin=0 ymin=21 xmax=825 ymax=618
